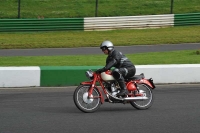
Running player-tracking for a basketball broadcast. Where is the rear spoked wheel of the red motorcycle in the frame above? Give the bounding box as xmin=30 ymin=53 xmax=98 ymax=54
xmin=130 ymin=84 xmax=153 ymax=110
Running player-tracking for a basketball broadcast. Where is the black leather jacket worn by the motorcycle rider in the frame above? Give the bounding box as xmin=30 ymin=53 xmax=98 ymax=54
xmin=104 ymin=49 xmax=135 ymax=70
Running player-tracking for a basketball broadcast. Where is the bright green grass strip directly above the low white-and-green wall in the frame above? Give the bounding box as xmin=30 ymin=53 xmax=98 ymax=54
xmin=0 ymin=49 xmax=200 ymax=66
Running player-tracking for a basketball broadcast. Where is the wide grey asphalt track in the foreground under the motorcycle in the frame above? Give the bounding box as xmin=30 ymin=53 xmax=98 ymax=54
xmin=0 ymin=84 xmax=200 ymax=133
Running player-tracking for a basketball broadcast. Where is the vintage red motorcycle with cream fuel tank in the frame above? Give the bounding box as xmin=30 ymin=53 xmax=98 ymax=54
xmin=73 ymin=70 xmax=155 ymax=113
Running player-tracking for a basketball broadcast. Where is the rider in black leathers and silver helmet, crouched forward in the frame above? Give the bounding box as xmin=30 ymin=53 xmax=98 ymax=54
xmin=96 ymin=41 xmax=136 ymax=96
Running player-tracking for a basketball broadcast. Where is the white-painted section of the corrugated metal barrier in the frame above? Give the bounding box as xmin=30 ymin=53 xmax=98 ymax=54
xmin=84 ymin=14 xmax=174 ymax=30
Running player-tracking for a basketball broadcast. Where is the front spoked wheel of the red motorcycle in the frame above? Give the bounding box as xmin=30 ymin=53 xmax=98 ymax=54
xmin=73 ymin=85 xmax=101 ymax=113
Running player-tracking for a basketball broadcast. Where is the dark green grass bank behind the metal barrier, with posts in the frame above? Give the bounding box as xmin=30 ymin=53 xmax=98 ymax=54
xmin=0 ymin=0 xmax=200 ymax=18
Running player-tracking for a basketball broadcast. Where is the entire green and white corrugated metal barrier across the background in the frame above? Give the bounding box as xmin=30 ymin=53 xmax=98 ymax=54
xmin=0 ymin=13 xmax=200 ymax=32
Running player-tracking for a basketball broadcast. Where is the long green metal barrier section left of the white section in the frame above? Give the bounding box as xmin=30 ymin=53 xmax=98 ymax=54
xmin=0 ymin=18 xmax=84 ymax=32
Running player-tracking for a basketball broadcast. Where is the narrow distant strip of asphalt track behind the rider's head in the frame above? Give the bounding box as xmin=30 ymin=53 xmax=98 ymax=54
xmin=0 ymin=43 xmax=200 ymax=56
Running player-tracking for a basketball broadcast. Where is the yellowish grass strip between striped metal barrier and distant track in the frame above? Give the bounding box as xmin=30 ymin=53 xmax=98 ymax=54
xmin=0 ymin=26 xmax=200 ymax=49
